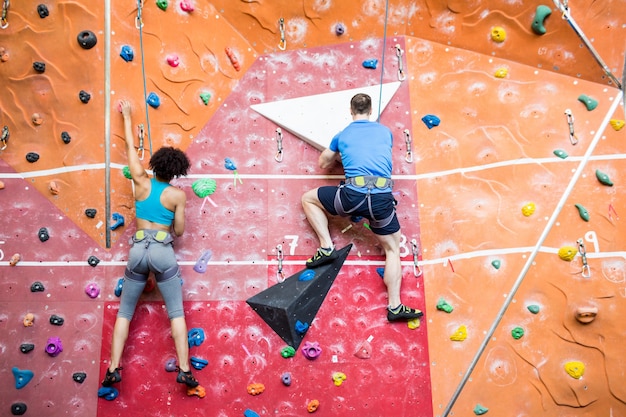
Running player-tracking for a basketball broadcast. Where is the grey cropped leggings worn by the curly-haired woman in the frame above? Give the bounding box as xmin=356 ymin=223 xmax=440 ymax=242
xmin=117 ymin=230 xmax=185 ymax=320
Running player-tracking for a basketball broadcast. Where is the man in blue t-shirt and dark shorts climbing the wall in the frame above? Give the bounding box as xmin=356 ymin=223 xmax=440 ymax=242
xmin=302 ymin=94 xmax=423 ymax=321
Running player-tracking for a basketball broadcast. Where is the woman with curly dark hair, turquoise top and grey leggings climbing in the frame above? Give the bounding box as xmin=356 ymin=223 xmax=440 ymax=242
xmin=102 ymin=100 xmax=198 ymax=388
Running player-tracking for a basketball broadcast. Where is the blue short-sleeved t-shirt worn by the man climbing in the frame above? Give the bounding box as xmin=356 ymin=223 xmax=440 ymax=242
xmin=328 ymin=120 xmax=393 ymax=193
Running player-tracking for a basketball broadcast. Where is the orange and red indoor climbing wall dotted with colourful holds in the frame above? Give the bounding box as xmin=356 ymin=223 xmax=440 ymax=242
xmin=0 ymin=0 xmax=626 ymax=416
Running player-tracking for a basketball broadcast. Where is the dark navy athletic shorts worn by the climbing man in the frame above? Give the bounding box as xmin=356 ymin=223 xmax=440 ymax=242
xmin=317 ymin=186 xmax=400 ymax=235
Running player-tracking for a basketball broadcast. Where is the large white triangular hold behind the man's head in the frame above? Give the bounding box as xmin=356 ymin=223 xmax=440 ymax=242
xmin=250 ymin=81 xmax=401 ymax=150
